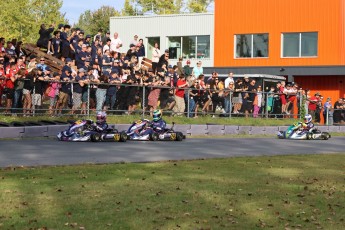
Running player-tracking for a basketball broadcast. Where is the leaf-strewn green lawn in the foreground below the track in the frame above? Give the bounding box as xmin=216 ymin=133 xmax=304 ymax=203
xmin=0 ymin=154 xmax=345 ymax=230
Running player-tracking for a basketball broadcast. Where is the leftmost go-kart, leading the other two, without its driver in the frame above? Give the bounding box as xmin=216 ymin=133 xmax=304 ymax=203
xmin=57 ymin=120 xmax=127 ymax=142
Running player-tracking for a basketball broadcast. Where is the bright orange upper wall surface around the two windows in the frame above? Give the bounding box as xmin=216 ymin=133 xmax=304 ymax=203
xmin=214 ymin=0 xmax=345 ymax=67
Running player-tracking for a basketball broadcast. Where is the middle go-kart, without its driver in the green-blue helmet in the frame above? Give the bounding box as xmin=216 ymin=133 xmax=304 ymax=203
xmin=126 ymin=119 xmax=186 ymax=141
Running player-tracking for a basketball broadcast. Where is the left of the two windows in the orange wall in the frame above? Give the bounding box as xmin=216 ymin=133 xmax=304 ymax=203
xmin=235 ymin=34 xmax=268 ymax=58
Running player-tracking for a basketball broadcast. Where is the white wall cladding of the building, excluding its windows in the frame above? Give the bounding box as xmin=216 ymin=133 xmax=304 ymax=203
xmin=110 ymin=13 xmax=214 ymax=67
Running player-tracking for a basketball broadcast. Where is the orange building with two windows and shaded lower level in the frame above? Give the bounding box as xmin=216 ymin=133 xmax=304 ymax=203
xmin=214 ymin=0 xmax=345 ymax=102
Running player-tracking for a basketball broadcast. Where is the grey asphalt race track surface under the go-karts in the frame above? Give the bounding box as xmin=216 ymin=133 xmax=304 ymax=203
xmin=0 ymin=137 xmax=345 ymax=167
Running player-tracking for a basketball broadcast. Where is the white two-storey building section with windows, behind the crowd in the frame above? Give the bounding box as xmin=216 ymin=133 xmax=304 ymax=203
xmin=110 ymin=13 xmax=214 ymax=67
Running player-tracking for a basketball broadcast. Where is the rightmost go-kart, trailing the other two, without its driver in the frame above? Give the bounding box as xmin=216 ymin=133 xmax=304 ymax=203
xmin=277 ymin=125 xmax=331 ymax=140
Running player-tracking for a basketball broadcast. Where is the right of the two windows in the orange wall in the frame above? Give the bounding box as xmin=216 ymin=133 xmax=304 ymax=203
xmin=282 ymin=32 xmax=318 ymax=57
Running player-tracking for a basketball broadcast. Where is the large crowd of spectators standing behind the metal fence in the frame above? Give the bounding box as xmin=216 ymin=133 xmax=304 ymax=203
xmin=0 ymin=24 xmax=344 ymax=123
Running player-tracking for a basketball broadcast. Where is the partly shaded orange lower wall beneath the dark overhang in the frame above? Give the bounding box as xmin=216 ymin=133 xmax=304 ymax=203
xmin=294 ymin=76 xmax=345 ymax=100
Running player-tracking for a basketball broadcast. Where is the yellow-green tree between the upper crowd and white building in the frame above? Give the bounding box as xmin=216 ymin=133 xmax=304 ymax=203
xmin=75 ymin=6 xmax=120 ymax=35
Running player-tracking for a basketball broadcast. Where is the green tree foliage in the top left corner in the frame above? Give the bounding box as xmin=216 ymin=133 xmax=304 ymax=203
xmin=0 ymin=0 xmax=65 ymax=43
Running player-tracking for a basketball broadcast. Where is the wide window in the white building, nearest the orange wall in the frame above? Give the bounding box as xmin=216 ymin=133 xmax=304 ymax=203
xmin=168 ymin=35 xmax=210 ymax=59
